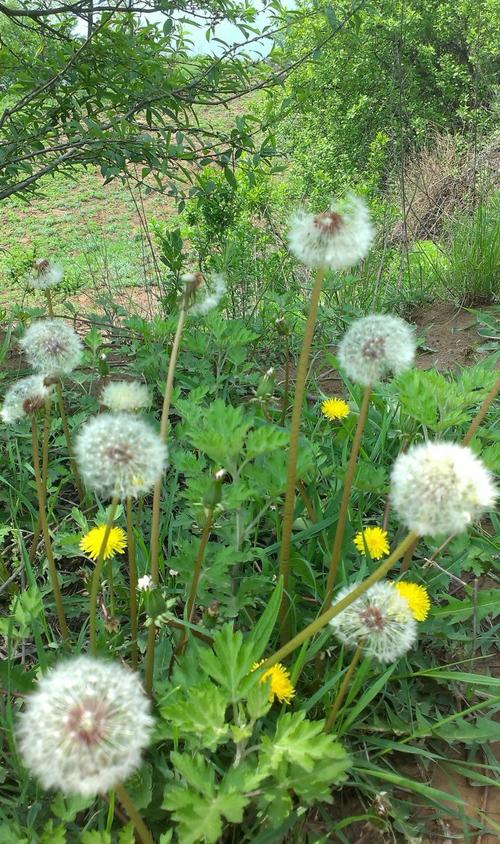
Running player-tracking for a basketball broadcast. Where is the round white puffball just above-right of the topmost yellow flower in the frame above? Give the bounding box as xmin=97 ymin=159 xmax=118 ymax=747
xmin=338 ymin=314 xmax=416 ymax=387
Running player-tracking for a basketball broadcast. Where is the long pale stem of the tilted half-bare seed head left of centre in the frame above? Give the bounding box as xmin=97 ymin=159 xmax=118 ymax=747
xmin=144 ymin=291 xmax=188 ymax=696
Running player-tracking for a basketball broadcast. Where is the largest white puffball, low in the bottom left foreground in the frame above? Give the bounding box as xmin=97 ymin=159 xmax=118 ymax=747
xmin=17 ymin=656 xmax=153 ymax=797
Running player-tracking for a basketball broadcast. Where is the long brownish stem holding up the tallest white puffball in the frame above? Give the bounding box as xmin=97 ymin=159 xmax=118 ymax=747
xmin=279 ymin=267 xmax=325 ymax=641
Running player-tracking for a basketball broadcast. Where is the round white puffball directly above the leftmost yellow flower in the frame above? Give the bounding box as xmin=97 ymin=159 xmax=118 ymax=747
xmin=75 ymin=413 xmax=168 ymax=499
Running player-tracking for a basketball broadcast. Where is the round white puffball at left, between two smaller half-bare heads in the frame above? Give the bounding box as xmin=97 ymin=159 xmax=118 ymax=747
xmin=19 ymin=319 xmax=83 ymax=377
